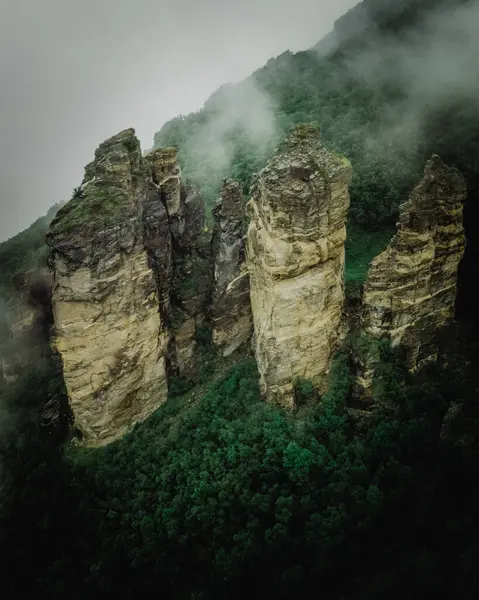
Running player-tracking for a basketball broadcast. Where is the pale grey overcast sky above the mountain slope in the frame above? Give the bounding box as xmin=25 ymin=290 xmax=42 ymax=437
xmin=0 ymin=0 xmax=357 ymax=240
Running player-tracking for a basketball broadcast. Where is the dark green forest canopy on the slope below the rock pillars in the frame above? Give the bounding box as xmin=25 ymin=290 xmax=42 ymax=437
xmin=2 ymin=340 xmax=479 ymax=600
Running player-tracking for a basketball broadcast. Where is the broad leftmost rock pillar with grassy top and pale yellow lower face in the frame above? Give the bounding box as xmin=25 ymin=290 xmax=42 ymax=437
xmin=47 ymin=129 xmax=168 ymax=445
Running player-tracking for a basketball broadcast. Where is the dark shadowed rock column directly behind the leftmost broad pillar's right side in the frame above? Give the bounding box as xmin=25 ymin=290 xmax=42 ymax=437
xmin=145 ymin=148 xmax=210 ymax=375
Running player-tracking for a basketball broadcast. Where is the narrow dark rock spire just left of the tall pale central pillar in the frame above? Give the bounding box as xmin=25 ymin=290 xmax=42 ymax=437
xmin=211 ymin=180 xmax=253 ymax=356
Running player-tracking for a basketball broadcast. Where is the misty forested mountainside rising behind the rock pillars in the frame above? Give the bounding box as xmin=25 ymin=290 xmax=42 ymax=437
xmin=155 ymin=0 xmax=479 ymax=304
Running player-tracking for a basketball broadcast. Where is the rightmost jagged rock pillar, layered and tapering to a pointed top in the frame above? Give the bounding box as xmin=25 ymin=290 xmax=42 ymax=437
xmin=358 ymin=155 xmax=466 ymax=399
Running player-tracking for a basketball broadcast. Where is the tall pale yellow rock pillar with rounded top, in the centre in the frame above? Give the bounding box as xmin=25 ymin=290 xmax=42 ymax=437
xmin=247 ymin=125 xmax=352 ymax=406
